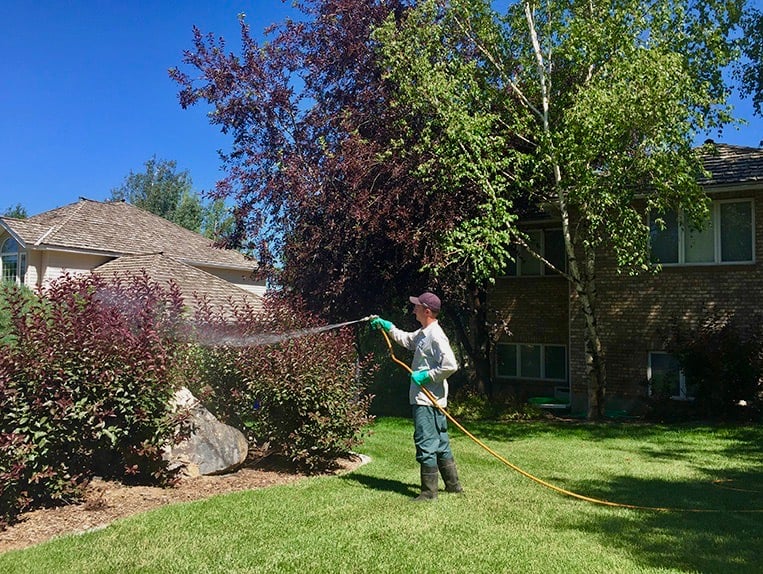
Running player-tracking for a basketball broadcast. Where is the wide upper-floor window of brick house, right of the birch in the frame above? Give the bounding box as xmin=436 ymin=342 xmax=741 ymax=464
xmin=649 ymin=199 xmax=755 ymax=265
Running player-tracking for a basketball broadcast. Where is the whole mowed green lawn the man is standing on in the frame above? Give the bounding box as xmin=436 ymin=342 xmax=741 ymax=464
xmin=0 ymin=419 xmax=763 ymax=574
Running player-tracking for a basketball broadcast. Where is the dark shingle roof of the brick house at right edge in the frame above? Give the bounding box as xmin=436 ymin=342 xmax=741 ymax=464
xmin=700 ymin=143 xmax=763 ymax=185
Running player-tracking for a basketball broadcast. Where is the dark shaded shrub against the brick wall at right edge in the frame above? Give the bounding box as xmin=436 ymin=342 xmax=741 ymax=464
xmin=668 ymin=310 xmax=763 ymax=418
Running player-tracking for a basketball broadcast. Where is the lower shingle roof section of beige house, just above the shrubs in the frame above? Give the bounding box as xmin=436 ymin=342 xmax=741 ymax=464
xmin=93 ymin=253 xmax=262 ymax=318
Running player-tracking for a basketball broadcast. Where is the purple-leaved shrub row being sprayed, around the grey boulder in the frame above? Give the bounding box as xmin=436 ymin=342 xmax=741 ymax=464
xmin=0 ymin=274 xmax=372 ymax=529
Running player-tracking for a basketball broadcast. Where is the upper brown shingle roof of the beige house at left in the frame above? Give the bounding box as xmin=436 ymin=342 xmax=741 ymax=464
xmin=4 ymin=199 xmax=256 ymax=270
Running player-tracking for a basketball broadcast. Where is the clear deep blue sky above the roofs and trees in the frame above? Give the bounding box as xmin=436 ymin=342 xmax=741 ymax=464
xmin=0 ymin=0 xmax=763 ymax=215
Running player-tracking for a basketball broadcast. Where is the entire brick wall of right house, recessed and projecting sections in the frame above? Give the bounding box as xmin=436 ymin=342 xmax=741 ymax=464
xmin=489 ymin=188 xmax=763 ymax=413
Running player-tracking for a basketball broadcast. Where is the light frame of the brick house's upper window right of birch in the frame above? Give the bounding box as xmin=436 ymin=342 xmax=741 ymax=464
xmin=648 ymin=197 xmax=756 ymax=267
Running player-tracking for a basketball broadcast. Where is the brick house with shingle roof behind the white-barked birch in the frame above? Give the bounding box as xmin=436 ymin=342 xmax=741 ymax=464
xmin=490 ymin=144 xmax=763 ymax=413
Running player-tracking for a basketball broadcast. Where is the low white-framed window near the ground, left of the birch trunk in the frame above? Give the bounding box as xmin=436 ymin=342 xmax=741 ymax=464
xmin=496 ymin=343 xmax=567 ymax=381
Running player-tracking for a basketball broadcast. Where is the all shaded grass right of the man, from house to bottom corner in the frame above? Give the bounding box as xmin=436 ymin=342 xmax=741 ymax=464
xmin=432 ymin=422 xmax=763 ymax=573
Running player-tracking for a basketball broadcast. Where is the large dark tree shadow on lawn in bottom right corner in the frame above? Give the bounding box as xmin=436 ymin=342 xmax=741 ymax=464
xmin=557 ymin=471 xmax=763 ymax=573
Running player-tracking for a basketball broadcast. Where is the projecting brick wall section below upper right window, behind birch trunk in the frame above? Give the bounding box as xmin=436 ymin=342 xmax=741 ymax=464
xmin=570 ymin=187 xmax=763 ymax=413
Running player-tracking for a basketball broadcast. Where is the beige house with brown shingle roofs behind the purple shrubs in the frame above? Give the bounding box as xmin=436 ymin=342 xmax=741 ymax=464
xmin=0 ymin=199 xmax=265 ymax=311
